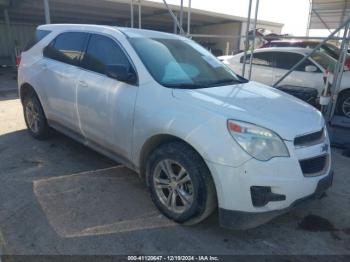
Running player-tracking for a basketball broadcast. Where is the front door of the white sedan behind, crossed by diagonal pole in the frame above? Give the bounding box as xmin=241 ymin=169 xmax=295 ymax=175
xmin=274 ymin=52 xmax=324 ymax=92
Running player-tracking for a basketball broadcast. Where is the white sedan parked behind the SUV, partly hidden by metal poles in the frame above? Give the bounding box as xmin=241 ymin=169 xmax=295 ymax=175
xmin=219 ymin=47 xmax=350 ymax=118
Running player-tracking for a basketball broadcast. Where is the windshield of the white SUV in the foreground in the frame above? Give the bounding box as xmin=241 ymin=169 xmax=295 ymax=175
xmin=129 ymin=38 xmax=247 ymax=88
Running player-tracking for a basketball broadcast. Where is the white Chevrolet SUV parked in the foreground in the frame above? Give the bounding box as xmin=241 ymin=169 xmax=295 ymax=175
xmin=18 ymin=25 xmax=333 ymax=229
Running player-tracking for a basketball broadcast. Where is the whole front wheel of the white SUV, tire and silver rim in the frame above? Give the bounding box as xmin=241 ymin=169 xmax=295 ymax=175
xmin=146 ymin=141 xmax=217 ymax=225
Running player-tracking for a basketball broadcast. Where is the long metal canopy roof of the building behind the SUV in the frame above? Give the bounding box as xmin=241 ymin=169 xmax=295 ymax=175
xmin=0 ymin=0 xmax=281 ymax=31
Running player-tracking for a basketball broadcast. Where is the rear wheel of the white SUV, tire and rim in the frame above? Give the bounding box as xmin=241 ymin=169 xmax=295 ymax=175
xmin=23 ymin=92 xmax=50 ymax=140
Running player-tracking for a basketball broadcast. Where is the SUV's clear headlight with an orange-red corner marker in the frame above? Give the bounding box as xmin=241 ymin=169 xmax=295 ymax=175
xmin=227 ymin=120 xmax=289 ymax=161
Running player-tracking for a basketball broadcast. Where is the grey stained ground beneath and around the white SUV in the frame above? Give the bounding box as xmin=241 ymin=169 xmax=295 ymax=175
xmin=0 ymin=74 xmax=350 ymax=261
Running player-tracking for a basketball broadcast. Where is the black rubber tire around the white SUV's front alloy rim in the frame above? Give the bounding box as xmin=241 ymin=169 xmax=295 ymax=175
xmin=146 ymin=141 xmax=217 ymax=224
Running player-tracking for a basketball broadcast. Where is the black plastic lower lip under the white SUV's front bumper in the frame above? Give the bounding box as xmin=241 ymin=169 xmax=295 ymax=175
xmin=219 ymin=171 xmax=333 ymax=230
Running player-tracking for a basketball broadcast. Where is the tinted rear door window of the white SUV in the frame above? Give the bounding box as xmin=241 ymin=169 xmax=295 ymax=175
xmin=44 ymin=32 xmax=88 ymax=66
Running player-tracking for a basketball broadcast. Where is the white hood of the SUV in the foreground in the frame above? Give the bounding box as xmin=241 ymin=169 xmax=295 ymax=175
xmin=173 ymin=81 xmax=324 ymax=140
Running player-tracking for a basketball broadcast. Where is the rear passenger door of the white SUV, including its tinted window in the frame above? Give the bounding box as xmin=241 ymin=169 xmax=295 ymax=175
xmin=40 ymin=32 xmax=88 ymax=133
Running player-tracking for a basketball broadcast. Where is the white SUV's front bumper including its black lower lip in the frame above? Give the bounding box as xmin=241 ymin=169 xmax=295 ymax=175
xmin=207 ymin=139 xmax=332 ymax=228
